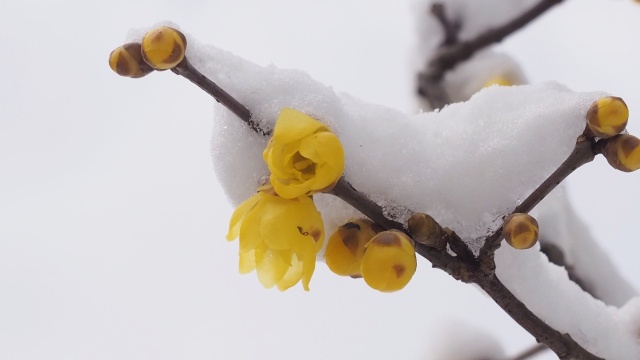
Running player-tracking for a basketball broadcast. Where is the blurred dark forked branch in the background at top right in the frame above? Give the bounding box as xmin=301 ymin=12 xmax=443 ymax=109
xmin=418 ymin=0 xmax=563 ymax=109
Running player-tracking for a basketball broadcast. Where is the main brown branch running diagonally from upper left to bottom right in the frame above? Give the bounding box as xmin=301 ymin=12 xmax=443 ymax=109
xmin=166 ymin=54 xmax=600 ymax=360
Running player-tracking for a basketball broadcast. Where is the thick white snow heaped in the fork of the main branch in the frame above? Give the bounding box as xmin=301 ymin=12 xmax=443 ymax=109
xmin=125 ymin=26 xmax=605 ymax=251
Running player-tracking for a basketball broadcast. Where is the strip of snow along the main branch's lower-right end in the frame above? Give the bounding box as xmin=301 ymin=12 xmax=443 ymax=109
xmin=496 ymin=245 xmax=640 ymax=360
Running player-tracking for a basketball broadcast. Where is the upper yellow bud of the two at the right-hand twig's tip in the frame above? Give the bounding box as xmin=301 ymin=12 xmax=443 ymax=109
xmin=587 ymin=96 xmax=629 ymax=138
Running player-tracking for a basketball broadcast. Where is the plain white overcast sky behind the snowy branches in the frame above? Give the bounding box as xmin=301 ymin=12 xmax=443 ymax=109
xmin=0 ymin=0 xmax=640 ymax=359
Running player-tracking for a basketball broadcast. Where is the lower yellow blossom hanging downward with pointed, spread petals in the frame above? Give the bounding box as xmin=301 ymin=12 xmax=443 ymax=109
xmin=227 ymin=186 xmax=324 ymax=291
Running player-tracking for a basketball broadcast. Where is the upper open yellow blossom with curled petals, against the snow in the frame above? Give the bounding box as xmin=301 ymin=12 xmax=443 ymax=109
xmin=263 ymin=108 xmax=344 ymax=199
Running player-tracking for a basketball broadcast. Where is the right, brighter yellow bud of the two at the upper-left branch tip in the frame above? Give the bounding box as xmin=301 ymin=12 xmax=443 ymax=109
xmin=142 ymin=26 xmax=187 ymax=70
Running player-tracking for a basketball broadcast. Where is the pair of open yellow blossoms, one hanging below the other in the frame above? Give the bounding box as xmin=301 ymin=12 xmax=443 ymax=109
xmin=227 ymin=108 xmax=344 ymax=291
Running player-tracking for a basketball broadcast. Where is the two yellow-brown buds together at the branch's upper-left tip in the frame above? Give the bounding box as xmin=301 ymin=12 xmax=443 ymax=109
xmin=109 ymin=26 xmax=187 ymax=78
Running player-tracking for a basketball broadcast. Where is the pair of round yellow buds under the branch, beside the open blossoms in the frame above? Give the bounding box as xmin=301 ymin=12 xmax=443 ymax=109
xmin=324 ymin=219 xmax=416 ymax=292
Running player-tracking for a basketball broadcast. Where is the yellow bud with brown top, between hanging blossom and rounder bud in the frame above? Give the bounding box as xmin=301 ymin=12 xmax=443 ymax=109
xmin=324 ymin=219 xmax=382 ymax=278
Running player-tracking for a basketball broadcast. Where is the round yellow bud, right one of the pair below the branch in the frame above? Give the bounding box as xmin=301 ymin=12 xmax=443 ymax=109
xmin=360 ymin=230 xmax=417 ymax=292
